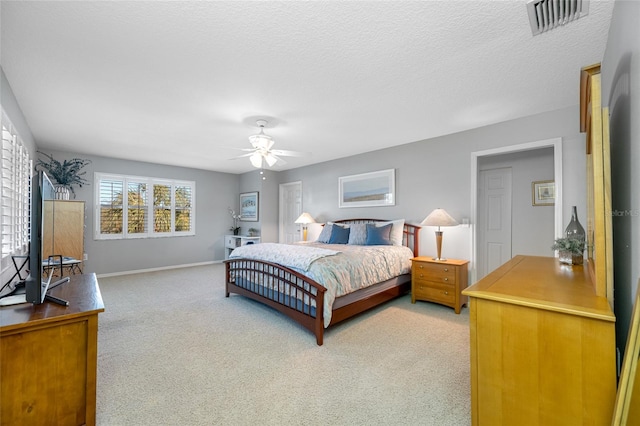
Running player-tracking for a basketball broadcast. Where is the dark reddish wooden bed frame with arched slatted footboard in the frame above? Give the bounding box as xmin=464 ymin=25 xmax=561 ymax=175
xmin=224 ymin=219 xmax=421 ymax=346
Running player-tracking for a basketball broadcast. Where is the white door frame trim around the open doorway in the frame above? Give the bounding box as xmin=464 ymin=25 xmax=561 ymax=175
xmin=470 ymin=138 xmax=563 ymax=283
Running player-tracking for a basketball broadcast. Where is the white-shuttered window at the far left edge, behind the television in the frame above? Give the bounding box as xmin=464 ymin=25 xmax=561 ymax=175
xmin=0 ymin=110 xmax=32 ymax=269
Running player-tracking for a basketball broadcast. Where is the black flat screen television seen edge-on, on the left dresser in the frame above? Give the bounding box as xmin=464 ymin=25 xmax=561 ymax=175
xmin=25 ymin=171 xmax=69 ymax=305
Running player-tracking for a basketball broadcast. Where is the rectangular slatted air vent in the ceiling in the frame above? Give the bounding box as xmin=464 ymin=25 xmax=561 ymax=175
xmin=527 ymin=0 xmax=589 ymax=35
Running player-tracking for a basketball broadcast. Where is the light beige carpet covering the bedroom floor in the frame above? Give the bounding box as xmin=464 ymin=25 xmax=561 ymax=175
xmin=97 ymin=264 xmax=470 ymax=426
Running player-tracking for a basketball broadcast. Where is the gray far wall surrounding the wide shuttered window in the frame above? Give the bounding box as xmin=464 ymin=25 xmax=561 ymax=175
xmin=35 ymin=151 xmax=240 ymax=274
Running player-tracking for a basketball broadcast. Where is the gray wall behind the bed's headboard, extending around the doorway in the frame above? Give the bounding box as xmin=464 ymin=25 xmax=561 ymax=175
xmin=274 ymin=105 xmax=586 ymax=268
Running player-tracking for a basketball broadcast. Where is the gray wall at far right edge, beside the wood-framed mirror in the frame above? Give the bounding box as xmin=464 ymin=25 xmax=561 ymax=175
xmin=602 ymin=1 xmax=640 ymax=353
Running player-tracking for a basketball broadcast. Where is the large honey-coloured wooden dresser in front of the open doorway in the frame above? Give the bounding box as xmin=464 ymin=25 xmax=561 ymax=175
xmin=463 ymin=256 xmax=616 ymax=426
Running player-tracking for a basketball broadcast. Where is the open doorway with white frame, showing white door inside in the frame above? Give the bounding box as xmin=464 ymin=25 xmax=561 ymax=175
xmin=470 ymin=138 xmax=562 ymax=282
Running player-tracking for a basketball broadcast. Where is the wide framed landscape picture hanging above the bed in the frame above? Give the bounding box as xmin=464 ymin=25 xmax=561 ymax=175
xmin=338 ymin=169 xmax=396 ymax=208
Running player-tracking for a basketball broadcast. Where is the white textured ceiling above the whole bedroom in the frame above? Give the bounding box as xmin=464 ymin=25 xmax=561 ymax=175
xmin=0 ymin=0 xmax=613 ymax=173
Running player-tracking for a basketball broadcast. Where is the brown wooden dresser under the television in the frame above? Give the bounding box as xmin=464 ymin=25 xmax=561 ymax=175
xmin=0 ymin=274 xmax=104 ymax=426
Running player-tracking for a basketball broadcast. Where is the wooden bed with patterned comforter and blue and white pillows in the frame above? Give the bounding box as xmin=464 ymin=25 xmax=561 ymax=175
xmin=224 ymin=219 xmax=420 ymax=345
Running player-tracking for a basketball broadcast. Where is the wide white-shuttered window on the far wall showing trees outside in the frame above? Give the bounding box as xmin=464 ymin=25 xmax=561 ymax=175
xmin=95 ymin=173 xmax=196 ymax=240
